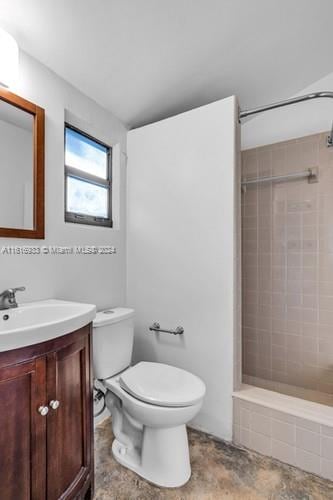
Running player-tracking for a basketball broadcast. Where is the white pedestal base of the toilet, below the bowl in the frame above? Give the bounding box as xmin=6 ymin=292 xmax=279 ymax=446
xmin=112 ymin=425 xmax=191 ymax=488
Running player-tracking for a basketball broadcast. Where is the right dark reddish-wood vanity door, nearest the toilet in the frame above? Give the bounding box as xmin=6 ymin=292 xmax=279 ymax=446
xmin=47 ymin=328 xmax=92 ymax=500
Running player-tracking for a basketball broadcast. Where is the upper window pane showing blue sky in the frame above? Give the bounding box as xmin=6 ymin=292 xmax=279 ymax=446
xmin=65 ymin=128 xmax=108 ymax=179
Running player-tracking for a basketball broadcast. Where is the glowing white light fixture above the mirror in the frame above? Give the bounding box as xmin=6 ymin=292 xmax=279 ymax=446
xmin=0 ymin=28 xmax=19 ymax=88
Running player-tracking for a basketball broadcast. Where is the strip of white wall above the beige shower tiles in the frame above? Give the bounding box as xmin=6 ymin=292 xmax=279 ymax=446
xmin=241 ymin=73 xmax=333 ymax=149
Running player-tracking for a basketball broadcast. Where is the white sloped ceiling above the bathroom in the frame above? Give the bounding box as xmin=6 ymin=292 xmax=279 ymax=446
xmin=0 ymin=0 xmax=333 ymax=128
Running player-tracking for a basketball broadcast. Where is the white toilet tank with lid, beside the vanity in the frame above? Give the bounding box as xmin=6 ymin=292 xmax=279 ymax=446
xmin=93 ymin=307 xmax=134 ymax=379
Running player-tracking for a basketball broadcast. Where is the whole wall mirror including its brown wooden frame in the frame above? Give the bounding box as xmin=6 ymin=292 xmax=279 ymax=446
xmin=0 ymin=89 xmax=44 ymax=239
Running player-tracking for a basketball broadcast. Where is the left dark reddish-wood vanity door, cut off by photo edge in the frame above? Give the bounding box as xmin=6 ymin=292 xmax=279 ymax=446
xmin=0 ymin=358 xmax=46 ymax=500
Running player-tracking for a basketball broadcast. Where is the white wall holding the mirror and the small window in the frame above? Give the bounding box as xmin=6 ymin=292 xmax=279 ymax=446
xmin=0 ymin=53 xmax=126 ymax=308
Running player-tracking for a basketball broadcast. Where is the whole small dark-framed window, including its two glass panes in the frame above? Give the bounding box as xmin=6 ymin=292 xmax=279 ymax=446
xmin=65 ymin=124 xmax=112 ymax=227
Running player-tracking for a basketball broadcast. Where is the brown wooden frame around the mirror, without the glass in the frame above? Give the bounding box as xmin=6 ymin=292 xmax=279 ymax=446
xmin=0 ymin=87 xmax=45 ymax=240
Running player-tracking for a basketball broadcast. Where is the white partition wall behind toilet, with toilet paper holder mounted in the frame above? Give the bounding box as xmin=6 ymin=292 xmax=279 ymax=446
xmin=127 ymin=97 xmax=237 ymax=439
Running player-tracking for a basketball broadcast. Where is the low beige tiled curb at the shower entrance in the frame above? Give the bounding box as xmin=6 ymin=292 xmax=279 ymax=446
xmin=233 ymin=384 xmax=333 ymax=481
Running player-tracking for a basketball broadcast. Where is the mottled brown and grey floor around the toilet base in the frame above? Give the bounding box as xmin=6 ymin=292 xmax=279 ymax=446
xmin=95 ymin=420 xmax=333 ymax=500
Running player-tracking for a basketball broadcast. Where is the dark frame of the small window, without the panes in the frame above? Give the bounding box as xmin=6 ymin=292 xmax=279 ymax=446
xmin=64 ymin=122 xmax=113 ymax=227
